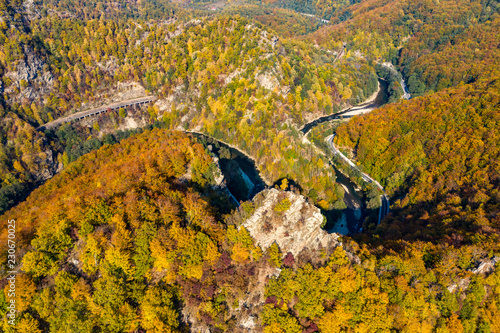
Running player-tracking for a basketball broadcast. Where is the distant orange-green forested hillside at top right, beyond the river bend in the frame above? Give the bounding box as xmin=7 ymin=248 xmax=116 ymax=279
xmin=314 ymin=0 xmax=500 ymax=96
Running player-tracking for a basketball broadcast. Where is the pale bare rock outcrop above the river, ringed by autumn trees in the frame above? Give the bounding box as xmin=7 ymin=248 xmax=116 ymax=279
xmin=243 ymin=189 xmax=340 ymax=256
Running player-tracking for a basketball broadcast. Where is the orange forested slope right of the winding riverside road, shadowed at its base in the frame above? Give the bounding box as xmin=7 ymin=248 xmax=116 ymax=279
xmin=336 ymin=75 xmax=500 ymax=246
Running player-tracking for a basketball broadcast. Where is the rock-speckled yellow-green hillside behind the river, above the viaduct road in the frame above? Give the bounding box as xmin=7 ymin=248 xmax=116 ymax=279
xmin=0 ymin=4 xmax=376 ymax=213
